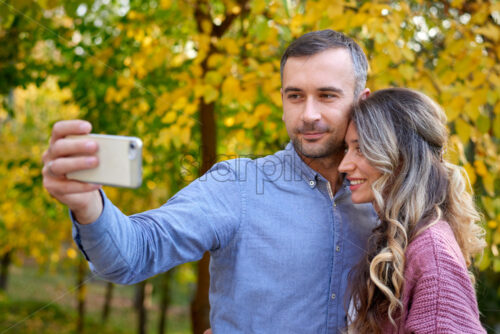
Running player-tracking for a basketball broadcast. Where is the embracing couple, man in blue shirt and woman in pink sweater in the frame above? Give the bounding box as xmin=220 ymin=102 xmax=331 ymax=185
xmin=43 ymin=30 xmax=484 ymax=333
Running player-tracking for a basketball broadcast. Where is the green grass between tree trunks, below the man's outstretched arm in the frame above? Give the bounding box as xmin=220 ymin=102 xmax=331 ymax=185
xmin=0 ymin=265 xmax=191 ymax=334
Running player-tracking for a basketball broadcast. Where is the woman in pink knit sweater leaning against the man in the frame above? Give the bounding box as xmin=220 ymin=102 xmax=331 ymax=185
xmin=339 ymin=88 xmax=485 ymax=333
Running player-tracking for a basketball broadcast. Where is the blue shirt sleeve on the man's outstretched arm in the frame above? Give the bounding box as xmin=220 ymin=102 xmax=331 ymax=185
xmin=71 ymin=161 xmax=242 ymax=284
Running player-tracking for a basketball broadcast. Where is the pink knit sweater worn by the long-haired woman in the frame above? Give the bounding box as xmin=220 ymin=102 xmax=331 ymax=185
xmin=386 ymin=221 xmax=486 ymax=334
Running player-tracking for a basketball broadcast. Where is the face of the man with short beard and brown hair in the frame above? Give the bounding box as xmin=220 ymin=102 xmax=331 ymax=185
xmin=281 ymin=48 xmax=360 ymax=158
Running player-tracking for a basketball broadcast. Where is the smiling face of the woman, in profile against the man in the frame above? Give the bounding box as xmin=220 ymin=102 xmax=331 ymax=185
xmin=339 ymin=122 xmax=382 ymax=203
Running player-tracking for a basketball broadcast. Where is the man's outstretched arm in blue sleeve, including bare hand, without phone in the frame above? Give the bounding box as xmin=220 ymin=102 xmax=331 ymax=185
xmin=42 ymin=120 xmax=241 ymax=283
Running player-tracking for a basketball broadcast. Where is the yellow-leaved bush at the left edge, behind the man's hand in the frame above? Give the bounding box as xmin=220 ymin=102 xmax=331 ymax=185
xmin=0 ymin=77 xmax=79 ymax=263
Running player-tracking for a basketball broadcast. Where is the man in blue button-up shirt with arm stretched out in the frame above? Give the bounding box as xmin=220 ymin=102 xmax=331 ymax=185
xmin=43 ymin=30 xmax=375 ymax=333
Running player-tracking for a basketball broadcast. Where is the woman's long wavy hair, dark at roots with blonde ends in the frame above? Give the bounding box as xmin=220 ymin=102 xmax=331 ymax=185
xmin=348 ymin=88 xmax=485 ymax=333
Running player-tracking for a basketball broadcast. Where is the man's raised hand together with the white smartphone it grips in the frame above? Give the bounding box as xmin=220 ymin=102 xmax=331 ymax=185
xmin=42 ymin=120 xmax=142 ymax=224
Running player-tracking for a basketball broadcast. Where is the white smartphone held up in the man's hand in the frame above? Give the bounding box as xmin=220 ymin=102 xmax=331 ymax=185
xmin=66 ymin=134 xmax=142 ymax=188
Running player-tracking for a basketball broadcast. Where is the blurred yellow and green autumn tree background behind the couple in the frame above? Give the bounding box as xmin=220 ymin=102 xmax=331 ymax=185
xmin=0 ymin=0 xmax=500 ymax=333
